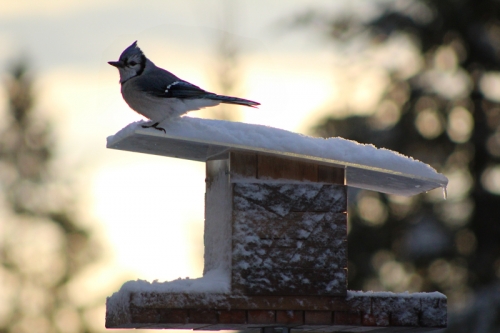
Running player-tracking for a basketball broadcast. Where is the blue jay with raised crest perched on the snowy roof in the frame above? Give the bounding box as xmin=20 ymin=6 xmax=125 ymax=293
xmin=108 ymin=41 xmax=260 ymax=132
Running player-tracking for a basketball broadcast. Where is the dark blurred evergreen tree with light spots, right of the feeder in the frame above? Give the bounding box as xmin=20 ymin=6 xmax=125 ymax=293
xmin=293 ymin=0 xmax=500 ymax=316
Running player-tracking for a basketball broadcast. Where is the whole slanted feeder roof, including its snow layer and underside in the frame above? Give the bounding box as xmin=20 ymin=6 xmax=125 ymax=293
xmin=107 ymin=117 xmax=448 ymax=196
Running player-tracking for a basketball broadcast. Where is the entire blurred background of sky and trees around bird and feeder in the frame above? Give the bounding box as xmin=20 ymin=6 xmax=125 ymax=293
xmin=0 ymin=0 xmax=500 ymax=333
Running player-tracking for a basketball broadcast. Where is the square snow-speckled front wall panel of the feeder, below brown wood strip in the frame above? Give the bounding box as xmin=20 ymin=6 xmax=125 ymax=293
xmin=231 ymin=183 xmax=347 ymax=296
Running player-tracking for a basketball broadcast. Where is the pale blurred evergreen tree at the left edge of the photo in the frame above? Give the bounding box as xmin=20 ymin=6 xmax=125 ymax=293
xmin=0 ymin=62 xmax=103 ymax=332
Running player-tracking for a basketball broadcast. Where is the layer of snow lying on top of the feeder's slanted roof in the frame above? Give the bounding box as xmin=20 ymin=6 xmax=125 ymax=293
xmin=107 ymin=117 xmax=448 ymax=186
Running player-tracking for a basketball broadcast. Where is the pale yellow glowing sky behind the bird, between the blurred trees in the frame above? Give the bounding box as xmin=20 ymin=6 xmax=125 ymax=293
xmin=0 ymin=0 xmax=384 ymax=282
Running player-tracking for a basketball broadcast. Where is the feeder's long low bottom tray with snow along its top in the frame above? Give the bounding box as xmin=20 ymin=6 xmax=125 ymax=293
xmin=106 ymin=281 xmax=447 ymax=332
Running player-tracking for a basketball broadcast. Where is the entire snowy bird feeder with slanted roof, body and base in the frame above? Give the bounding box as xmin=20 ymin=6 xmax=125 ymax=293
xmin=106 ymin=117 xmax=447 ymax=332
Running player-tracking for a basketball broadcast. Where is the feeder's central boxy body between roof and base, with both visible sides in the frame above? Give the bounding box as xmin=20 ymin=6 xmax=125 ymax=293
xmin=204 ymin=152 xmax=347 ymax=296
